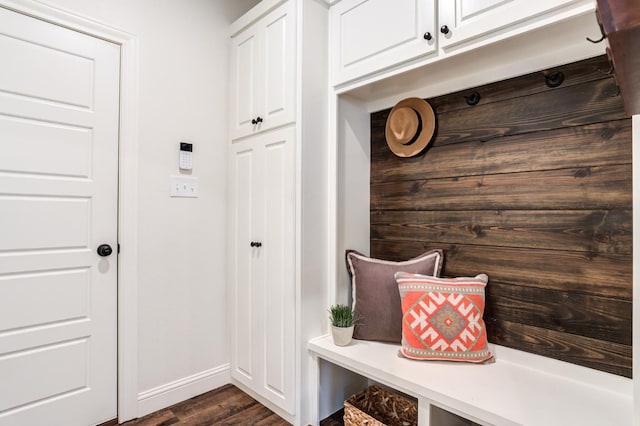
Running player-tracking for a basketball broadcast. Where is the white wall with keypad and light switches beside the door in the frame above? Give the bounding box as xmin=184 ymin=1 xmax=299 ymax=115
xmin=30 ymin=0 xmax=257 ymax=414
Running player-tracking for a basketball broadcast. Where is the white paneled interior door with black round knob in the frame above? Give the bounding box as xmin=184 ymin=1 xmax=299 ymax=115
xmin=0 ymin=7 xmax=120 ymax=426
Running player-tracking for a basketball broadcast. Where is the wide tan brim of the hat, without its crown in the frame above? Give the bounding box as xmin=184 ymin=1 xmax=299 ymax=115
xmin=385 ymin=98 xmax=436 ymax=157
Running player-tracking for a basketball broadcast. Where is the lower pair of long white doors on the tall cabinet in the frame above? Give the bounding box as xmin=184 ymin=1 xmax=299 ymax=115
xmin=229 ymin=127 xmax=296 ymax=414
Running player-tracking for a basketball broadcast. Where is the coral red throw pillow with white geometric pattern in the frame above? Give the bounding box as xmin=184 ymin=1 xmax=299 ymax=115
xmin=395 ymin=272 xmax=492 ymax=363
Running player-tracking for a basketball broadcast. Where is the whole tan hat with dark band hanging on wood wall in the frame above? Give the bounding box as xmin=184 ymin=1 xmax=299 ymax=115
xmin=385 ymin=98 xmax=436 ymax=157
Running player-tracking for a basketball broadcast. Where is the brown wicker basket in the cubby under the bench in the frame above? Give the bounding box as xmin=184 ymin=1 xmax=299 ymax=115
xmin=344 ymin=386 xmax=418 ymax=426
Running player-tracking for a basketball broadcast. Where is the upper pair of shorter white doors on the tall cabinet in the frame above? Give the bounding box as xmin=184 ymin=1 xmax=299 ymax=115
xmin=230 ymin=2 xmax=295 ymax=139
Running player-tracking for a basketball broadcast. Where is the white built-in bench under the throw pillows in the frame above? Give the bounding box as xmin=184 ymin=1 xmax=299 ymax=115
xmin=308 ymin=336 xmax=633 ymax=426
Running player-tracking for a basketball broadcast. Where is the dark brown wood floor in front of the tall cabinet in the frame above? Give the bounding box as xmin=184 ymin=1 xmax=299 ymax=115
xmin=101 ymin=385 xmax=289 ymax=426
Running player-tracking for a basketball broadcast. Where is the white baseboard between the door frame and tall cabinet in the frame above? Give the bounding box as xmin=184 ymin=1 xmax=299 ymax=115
xmin=138 ymin=364 xmax=231 ymax=417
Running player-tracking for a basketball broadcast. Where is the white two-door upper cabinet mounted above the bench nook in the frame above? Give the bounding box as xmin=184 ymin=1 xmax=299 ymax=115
xmin=330 ymin=0 xmax=594 ymax=86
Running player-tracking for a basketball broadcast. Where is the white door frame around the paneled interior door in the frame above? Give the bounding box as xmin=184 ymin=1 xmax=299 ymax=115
xmin=0 ymin=0 xmax=139 ymax=422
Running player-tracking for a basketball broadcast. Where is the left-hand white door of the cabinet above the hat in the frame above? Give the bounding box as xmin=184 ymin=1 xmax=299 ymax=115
xmin=330 ymin=0 xmax=438 ymax=85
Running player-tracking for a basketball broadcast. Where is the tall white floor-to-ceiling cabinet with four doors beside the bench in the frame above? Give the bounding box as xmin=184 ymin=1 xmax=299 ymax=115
xmin=228 ymin=0 xmax=328 ymax=424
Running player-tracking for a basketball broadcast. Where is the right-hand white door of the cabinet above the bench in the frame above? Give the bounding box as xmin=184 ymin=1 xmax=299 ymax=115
xmin=438 ymin=0 xmax=585 ymax=51
